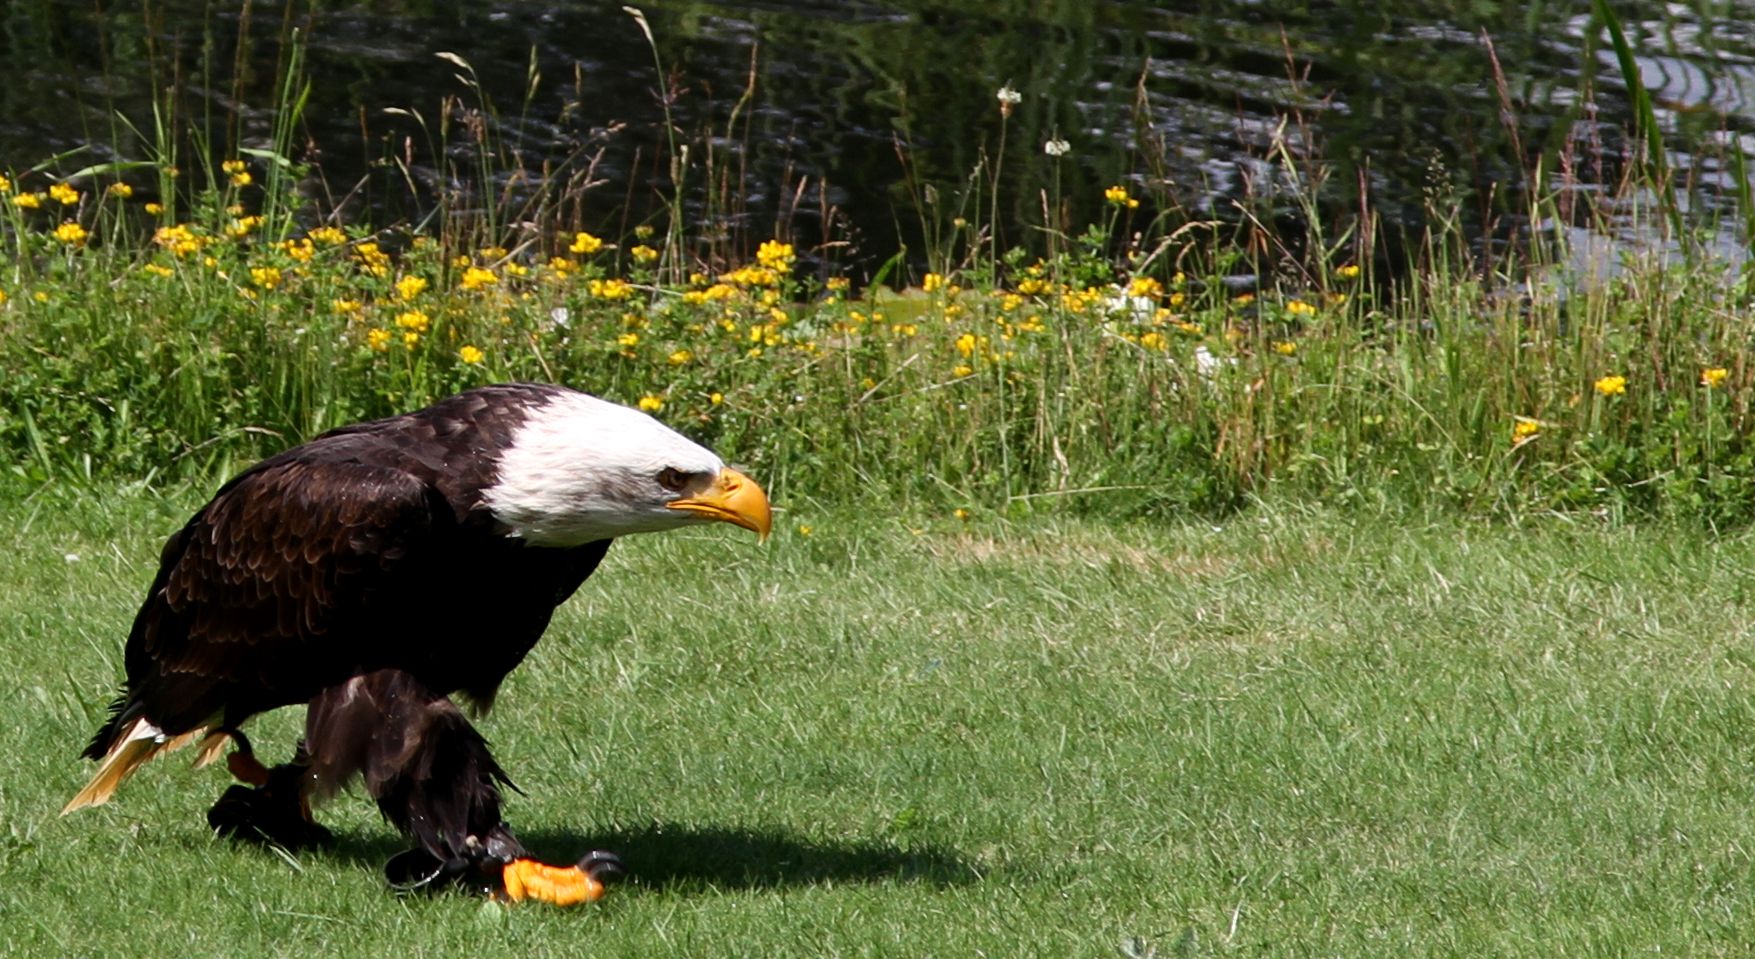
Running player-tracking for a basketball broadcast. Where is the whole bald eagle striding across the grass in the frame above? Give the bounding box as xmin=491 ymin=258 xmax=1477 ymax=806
xmin=63 ymin=377 xmax=769 ymax=903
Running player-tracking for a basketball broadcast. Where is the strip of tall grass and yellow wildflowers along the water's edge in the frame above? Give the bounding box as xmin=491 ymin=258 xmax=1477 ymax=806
xmin=0 ymin=7 xmax=1755 ymax=523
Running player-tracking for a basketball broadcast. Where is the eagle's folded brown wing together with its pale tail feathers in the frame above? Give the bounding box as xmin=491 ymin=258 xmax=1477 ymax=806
xmin=75 ymin=448 xmax=455 ymax=804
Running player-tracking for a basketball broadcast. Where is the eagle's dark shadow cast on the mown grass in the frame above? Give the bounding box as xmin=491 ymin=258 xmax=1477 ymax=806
xmin=321 ymin=824 xmax=979 ymax=891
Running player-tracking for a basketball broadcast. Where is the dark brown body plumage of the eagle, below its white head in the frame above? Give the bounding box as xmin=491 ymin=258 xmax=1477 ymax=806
xmin=86 ymin=385 xmax=609 ymax=859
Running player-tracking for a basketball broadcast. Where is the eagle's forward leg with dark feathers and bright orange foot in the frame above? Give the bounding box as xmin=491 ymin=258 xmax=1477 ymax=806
xmin=305 ymin=669 xmax=621 ymax=905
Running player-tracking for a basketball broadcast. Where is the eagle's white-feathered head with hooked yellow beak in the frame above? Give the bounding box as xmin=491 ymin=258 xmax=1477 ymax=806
xmin=483 ymin=392 xmax=770 ymax=546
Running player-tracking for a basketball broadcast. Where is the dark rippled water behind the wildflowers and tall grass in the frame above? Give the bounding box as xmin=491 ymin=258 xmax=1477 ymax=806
xmin=0 ymin=0 xmax=1755 ymax=270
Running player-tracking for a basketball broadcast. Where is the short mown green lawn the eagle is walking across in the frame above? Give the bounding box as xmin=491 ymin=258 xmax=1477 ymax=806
xmin=0 ymin=494 xmax=1755 ymax=959
